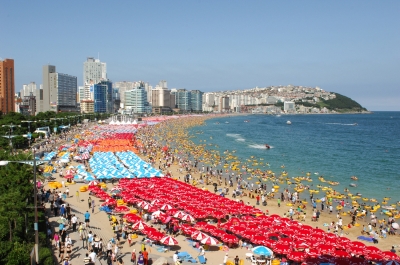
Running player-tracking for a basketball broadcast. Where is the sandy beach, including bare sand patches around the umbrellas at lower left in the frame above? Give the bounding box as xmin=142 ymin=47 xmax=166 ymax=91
xmin=42 ymin=116 xmax=398 ymax=264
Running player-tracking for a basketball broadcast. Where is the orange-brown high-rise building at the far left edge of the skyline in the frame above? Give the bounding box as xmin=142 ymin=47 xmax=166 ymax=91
xmin=0 ymin=59 xmax=15 ymax=113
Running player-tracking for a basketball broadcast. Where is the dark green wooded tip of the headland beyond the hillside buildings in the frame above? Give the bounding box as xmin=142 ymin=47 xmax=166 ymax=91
xmin=317 ymin=92 xmax=367 ymax=112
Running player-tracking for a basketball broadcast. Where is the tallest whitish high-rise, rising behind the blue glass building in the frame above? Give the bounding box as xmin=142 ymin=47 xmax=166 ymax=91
xmin=83 ymin=57 xmax=107 ymax=84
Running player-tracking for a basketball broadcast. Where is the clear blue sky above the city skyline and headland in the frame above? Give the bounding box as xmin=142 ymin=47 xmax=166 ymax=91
xmin=0 ymin=0 xmax=400 ymax=111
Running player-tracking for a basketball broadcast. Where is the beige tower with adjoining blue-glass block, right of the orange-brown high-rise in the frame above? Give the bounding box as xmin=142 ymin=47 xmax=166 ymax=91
xmin=41 ymin=65 xmax=78 ymax=112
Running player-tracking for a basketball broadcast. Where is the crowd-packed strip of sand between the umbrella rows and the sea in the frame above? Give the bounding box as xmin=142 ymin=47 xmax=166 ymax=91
xmin=38 ymin=116 xmax=398 ymax=264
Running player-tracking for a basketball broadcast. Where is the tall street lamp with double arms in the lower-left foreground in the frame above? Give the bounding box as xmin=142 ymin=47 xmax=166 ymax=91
xmin=0 ymin=150 xmax=50 ymax=264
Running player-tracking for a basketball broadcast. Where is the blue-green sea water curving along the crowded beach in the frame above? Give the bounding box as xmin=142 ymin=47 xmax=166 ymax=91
xmin=190 ymin=112 xmax=400 ymax=203
